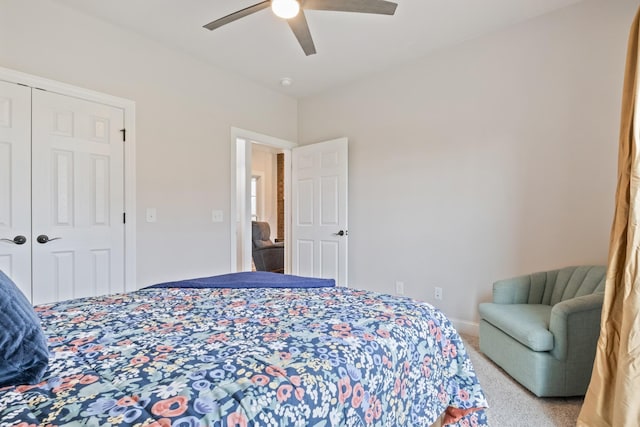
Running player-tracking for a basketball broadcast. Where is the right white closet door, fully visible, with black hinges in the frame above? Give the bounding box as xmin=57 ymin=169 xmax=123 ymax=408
xmin=32 ymin=89 xmax=125 ymax=304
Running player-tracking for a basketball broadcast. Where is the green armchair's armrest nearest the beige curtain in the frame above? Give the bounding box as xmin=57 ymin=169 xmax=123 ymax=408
xmin=549 ymin=292 xmax=604 ymax=360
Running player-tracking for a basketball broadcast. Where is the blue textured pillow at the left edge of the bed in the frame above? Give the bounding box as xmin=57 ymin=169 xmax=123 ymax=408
xmin=0 ymin=271 xmax=49 ymax=387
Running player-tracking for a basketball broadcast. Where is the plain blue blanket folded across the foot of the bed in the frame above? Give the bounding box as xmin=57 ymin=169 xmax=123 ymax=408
xmin=148 ymin=271 xmax=336 ymax=288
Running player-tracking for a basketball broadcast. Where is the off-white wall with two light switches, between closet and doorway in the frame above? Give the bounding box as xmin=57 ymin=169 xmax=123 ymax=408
xmin=0 ymin=0 xmax=297 ymax=286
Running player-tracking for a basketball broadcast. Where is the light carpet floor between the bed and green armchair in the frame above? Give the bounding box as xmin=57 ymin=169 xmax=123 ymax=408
xmin=462 ymin=335 xmax=583 ymax=427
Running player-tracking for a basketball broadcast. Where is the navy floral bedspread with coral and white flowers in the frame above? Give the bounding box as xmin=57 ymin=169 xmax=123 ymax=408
xmin=0 ymin=288 xmax=487 ymax=427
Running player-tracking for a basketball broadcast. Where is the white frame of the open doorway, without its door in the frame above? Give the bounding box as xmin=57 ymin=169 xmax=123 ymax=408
xmin=229 ymin=127 xmax=298 ymax=273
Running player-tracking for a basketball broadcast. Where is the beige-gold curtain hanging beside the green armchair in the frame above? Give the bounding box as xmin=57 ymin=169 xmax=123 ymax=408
xmin=578 ymin=5 xmax=640 ymax=427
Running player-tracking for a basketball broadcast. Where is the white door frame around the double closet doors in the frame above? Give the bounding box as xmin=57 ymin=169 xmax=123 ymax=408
xmin=0 ymin=67 xmax=138 ymax=292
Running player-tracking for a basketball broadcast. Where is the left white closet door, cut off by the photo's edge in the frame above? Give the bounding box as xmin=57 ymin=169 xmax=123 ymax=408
xmin=0 ymin=81 xmax=31 ymax=299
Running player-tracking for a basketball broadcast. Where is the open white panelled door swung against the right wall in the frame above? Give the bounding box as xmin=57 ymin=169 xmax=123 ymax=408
xmin=291 ymin=138 xmax=348 ymax=286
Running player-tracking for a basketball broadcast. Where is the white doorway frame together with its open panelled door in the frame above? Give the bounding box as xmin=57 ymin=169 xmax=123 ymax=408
xmin=230 ymin=128 xmax=348 ymax=286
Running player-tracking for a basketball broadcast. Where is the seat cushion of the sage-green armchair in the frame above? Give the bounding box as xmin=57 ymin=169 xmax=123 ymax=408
xmin=480 ymin=303 xmax=553 ymax=351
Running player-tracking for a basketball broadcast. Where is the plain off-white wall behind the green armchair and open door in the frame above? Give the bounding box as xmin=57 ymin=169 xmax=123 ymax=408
xmin=298 ymin=0 xmax=638 ymax=328
